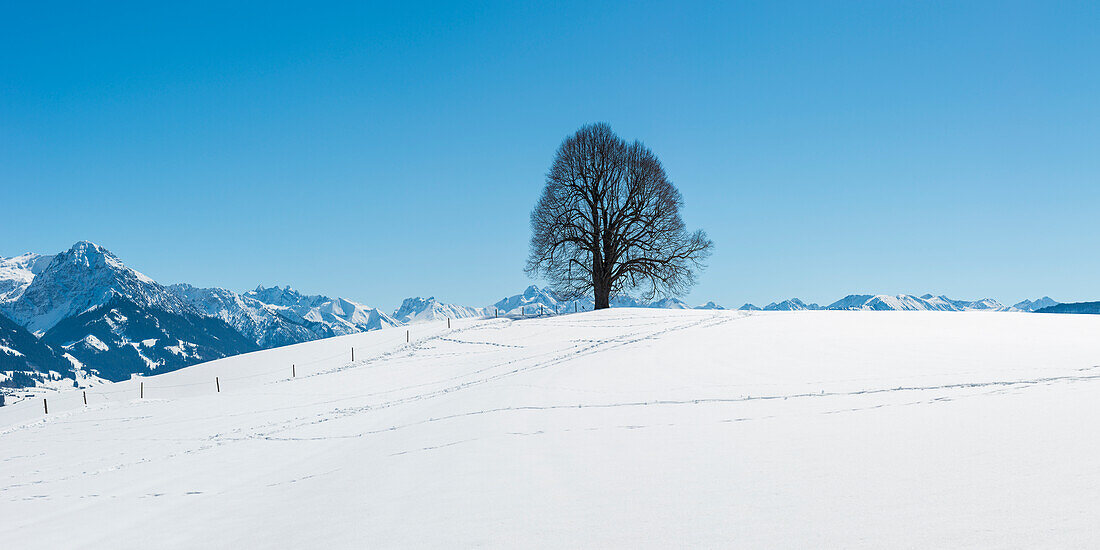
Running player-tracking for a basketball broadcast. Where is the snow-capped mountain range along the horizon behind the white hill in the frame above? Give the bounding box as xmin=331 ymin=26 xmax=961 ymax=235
xmin=0 ymin=241 xmax=1082 ymax=394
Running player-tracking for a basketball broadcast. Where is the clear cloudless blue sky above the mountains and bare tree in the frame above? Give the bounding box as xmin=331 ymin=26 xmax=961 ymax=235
xmin=0 ymin=1 xmax=1100 ymax=309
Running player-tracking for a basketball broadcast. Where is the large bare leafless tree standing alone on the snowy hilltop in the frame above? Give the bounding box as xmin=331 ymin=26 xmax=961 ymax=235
xmin=527 ymin=123 xmax=713 ymax=309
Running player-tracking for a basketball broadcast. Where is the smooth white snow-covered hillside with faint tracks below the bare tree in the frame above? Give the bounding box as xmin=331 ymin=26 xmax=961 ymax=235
xmin=0 ymin=309 xmax=1100 ymax=549
